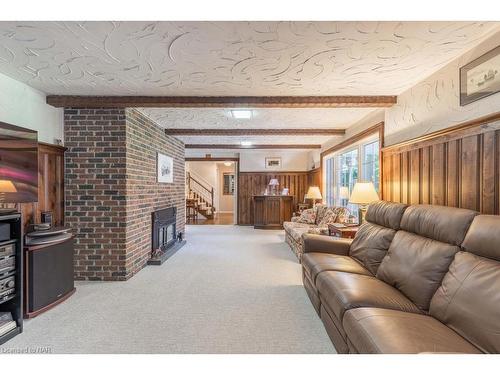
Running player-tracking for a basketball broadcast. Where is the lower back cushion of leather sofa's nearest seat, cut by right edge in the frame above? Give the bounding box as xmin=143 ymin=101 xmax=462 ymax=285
xmin=429 ymin=253 xmax=500 ymax=353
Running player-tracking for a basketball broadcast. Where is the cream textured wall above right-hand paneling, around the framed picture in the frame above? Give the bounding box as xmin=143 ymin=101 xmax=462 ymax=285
xmin=385 ymin=32 xmax=500 ymax=145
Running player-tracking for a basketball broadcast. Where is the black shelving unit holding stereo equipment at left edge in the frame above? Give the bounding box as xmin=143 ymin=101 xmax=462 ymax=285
xmin=0 ymin=213 xmax=23 ymax=345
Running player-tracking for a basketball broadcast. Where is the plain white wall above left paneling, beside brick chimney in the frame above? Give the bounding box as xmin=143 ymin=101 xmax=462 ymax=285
xmin=0 ymin=74 xmax=64 ymax=143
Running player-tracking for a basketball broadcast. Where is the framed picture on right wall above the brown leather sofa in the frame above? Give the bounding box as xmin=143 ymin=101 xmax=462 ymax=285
xmin=460 ymin=46 xmax=500 ymax=106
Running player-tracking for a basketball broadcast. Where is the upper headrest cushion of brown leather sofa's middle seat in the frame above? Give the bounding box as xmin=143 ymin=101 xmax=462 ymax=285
xmin=401 ymin=205 xmax=478 ymax=246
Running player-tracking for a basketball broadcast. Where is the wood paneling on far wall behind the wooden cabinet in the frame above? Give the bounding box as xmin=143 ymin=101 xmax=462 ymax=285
xmin=238 ymin=172 xmax=310 ymax=225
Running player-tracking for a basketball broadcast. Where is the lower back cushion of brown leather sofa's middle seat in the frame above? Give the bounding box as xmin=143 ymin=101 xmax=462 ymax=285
xmin=377 ymin=230 xmax=459 ymax=310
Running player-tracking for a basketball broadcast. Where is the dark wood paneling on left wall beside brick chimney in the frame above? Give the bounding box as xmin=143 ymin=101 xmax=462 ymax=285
xmin=1 ymin=143 xmax=66 ymax=231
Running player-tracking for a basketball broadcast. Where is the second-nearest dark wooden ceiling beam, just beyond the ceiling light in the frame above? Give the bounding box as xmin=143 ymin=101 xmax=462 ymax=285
xmin=165 ymin=128 xmax=345 ymax=137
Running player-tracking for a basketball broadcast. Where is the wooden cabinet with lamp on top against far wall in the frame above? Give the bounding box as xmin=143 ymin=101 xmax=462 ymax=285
xmin=253 ymin=195 xmax=293 ymax=229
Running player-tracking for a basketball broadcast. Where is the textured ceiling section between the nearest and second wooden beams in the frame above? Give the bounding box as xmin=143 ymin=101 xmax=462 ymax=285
xmin=139 ymin=108 xmax=377 ymax=129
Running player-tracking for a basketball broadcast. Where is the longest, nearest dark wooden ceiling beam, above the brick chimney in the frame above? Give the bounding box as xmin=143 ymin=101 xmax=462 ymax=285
xmin=46 ymin=95 xmax=397 ymax=108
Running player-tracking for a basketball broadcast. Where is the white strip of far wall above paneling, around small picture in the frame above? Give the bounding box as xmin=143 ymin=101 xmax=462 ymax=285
xmin=240 ymin=150 xmax=311 ymax=172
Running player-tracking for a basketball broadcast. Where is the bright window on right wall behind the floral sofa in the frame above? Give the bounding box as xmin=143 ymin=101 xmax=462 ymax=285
xmin=323 ymin=138 xmax=380 ymax=216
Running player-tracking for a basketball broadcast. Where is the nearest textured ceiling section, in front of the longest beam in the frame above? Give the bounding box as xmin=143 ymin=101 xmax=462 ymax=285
xmin=0 ymin=22 xmax=498 ymax=96
